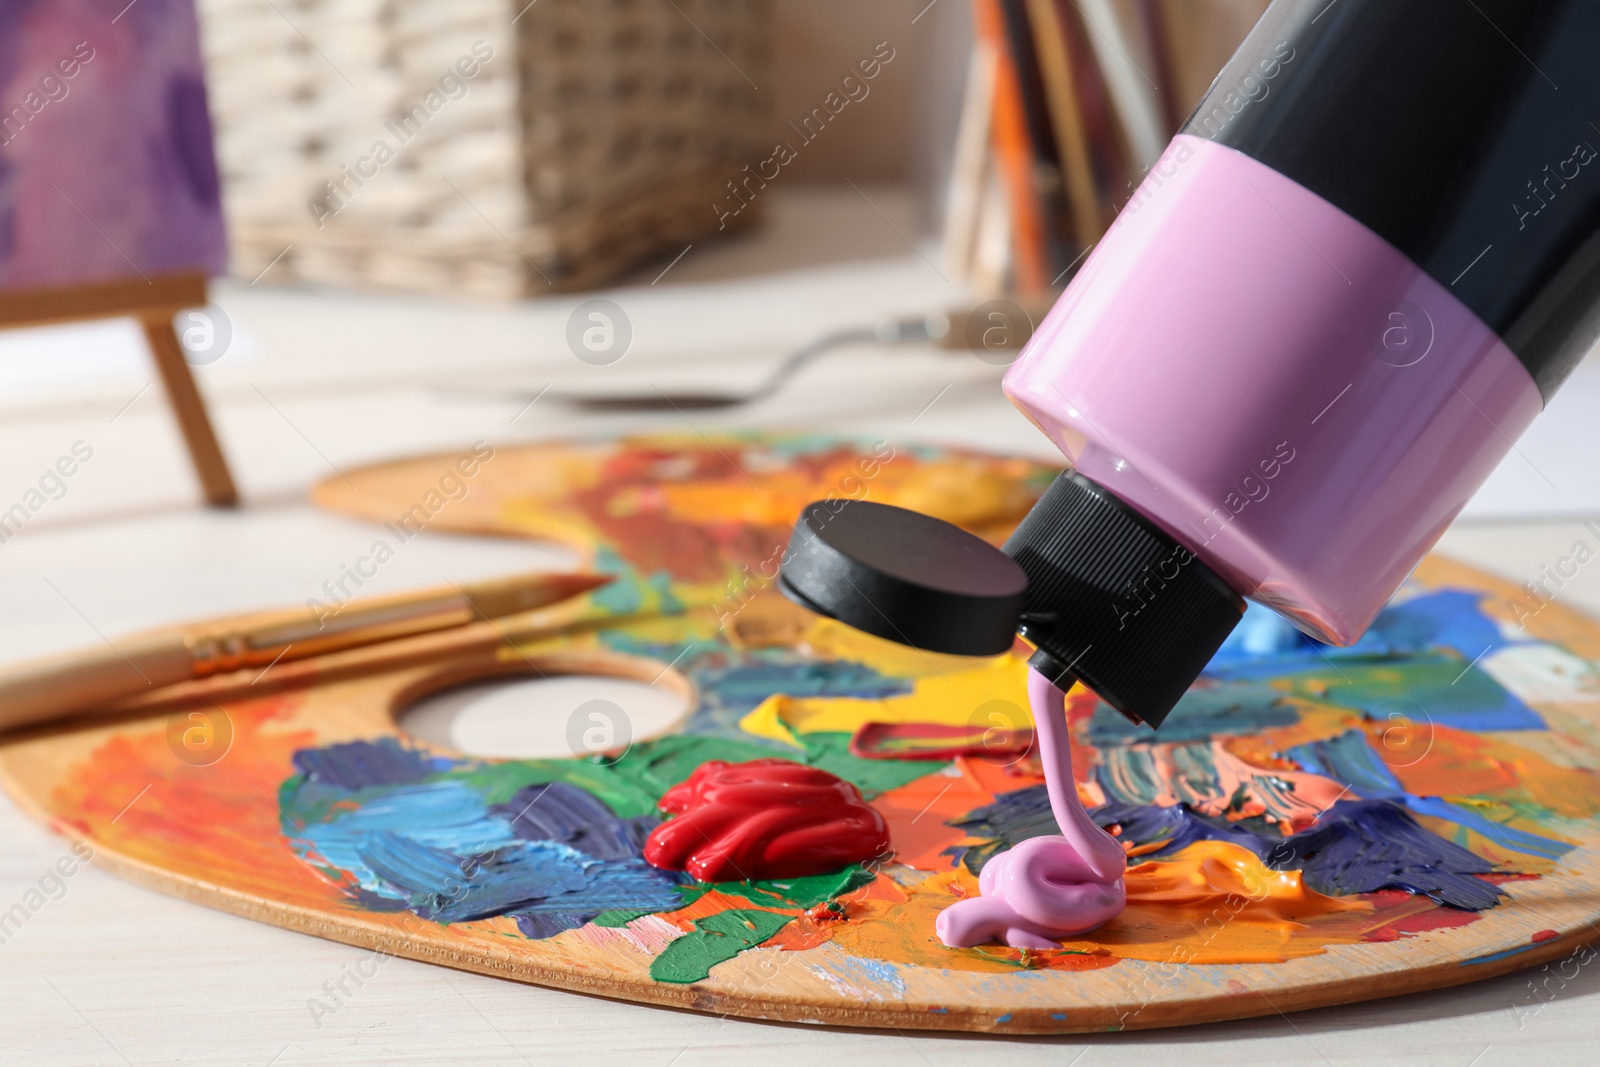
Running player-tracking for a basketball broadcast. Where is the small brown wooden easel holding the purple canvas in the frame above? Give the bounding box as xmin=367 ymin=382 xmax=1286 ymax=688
xmin=0 ymin=274 xmax=238 ymax=507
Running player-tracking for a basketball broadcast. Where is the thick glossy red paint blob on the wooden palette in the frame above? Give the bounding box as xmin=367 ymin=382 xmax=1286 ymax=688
xmin=645 ymin=760 xmax=890 ymax=881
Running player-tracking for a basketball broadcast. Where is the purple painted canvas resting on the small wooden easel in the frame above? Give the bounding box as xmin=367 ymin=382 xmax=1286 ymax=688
xmin=0 ymin=0 xmax=227 ymax=290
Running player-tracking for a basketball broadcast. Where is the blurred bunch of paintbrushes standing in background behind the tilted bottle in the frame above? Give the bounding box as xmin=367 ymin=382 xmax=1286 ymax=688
xmin=941 ymin=0 xmax=1267 ymax=293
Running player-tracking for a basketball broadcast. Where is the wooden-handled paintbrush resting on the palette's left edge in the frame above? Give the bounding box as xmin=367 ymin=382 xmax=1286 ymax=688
xmin=0 ymin=574 xmax=611 ymax=731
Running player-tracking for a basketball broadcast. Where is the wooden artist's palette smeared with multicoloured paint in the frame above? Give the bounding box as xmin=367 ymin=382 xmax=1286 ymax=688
xmin=0 ymin=437 xmax=1600 ymax=1033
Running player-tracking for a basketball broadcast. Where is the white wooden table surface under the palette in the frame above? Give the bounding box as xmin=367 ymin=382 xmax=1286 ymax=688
xmin=0 ymin=189 xmax=1600 ymax=1067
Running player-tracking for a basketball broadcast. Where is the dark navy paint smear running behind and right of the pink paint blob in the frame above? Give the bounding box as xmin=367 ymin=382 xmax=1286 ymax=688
xmin=946 ymin=785 xmax=1502 ymax=912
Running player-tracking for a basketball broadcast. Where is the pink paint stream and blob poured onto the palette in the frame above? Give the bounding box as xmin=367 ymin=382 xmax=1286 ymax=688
xmin=934 ymin=672 xmax=1128 ymax=949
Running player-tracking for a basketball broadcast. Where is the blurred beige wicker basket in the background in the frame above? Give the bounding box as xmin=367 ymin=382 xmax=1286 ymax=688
xmin=198 ymin=0 xmax=770 ymax=298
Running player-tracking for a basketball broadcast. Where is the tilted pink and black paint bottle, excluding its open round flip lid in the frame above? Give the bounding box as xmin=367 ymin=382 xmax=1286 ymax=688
xmin=1005 ymin=0 xmax=1600 ymax=725
